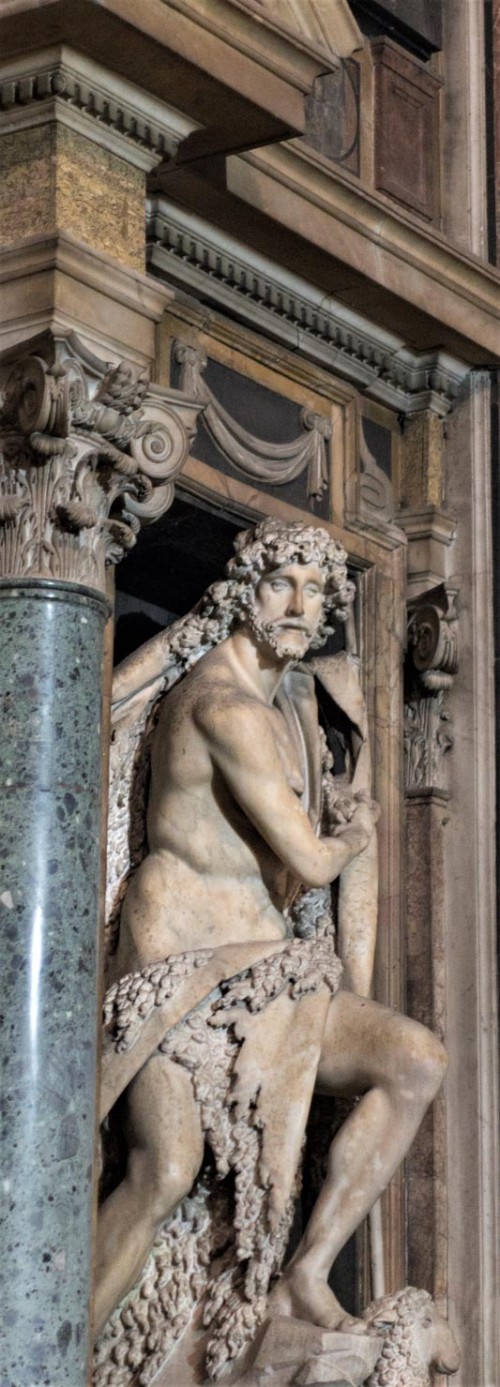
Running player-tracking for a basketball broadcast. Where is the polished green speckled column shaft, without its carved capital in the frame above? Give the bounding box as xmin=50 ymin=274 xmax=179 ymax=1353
xmin=0 ymin=583 xmax=104 ymax=1387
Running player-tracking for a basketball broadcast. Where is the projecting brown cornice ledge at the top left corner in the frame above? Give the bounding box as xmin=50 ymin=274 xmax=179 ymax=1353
xmin=0 ymin=0 xmax=335 ymax=148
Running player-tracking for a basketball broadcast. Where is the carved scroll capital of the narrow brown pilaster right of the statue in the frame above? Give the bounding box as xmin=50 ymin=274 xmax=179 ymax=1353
xmin=404 ymin=583 xmax=458 ymax=795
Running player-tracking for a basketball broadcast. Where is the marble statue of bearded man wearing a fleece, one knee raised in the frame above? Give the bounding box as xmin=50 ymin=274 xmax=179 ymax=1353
xmin=94 ymin=520 xmax=444 ymax=1387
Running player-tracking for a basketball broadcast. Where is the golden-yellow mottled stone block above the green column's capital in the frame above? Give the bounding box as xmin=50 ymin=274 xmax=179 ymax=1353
xmin=0 ymin=121 xmax=144 ymax=270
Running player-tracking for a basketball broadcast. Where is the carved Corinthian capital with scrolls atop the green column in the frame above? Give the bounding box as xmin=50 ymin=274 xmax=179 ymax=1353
xmin=0 ymin=334 xmax=203 ymax=591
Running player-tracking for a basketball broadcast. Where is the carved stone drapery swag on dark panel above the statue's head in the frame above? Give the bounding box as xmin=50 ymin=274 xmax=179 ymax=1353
xmin=175 ymin=343 xmax=332 ymax=501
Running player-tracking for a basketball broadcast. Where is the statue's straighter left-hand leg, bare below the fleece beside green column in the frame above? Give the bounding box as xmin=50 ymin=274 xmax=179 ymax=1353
xmin=94 ymin=1054 xmax=204 ymax=1334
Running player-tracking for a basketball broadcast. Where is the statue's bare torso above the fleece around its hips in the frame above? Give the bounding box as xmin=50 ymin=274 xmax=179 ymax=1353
xmin=117 ymin=655 xmax=304 ymax=972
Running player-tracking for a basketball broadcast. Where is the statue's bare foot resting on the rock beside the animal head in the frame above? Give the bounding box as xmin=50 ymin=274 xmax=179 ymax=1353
xmin=269 ymin=1262 xmax=368 ymax=1334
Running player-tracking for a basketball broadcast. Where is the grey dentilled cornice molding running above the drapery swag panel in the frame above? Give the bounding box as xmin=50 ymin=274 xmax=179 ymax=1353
xmin=147 ymin=197 xmax=468 ymax=416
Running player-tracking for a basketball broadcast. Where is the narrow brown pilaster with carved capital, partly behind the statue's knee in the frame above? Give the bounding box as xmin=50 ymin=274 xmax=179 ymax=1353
xmin=404 ymin=584 xmax=458 ymax=1312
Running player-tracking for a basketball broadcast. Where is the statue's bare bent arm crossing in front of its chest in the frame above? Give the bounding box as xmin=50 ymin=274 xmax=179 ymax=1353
xmin=194 ymin=698 xmax=374 ymax=886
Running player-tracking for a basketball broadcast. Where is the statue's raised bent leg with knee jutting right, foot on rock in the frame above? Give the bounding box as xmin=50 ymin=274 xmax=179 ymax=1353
xmin=274 ymin=992 xmax=446 ymax=1330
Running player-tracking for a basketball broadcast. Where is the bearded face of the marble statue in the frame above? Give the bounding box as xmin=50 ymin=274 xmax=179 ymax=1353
xmin=249 ymin=563 xmax=325 ymax=660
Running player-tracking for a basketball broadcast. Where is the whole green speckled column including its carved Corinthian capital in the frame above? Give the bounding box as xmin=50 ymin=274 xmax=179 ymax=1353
xmin=0 ymin=336 xmax=200 ymax=1387
